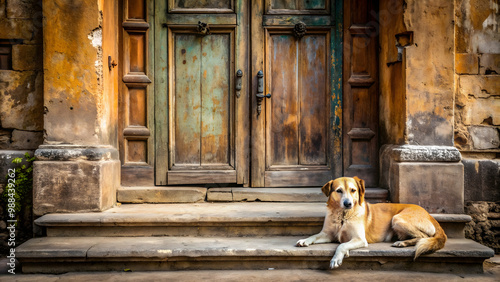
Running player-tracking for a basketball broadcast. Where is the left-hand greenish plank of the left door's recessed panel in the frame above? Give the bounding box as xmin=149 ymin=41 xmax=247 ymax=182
xmin=174 ymin=34 xmax=202 ymax=164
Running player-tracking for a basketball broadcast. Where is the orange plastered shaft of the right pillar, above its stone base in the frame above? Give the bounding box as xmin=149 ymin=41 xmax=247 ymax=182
xmin=379 ymin=0 xmax=454 ymax=146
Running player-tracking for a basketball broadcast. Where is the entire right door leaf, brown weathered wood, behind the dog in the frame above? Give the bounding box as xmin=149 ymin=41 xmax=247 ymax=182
xmin=251 ymin=0 xmax=342 ymax=187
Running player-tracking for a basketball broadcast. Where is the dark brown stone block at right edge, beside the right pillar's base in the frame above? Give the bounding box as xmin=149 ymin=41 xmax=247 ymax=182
xmin=462 ymin=159 xmax=500 ymax=202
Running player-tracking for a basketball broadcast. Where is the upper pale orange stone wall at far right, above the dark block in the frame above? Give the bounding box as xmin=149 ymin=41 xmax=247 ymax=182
xmin=455 ymin=0 xmax=500 ymax=152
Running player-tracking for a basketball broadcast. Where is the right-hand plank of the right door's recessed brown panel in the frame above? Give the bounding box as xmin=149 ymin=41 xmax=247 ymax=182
xmin=299 ymin=34 xmax=329 ymax=165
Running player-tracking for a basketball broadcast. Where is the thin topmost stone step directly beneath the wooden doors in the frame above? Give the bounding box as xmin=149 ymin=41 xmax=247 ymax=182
xmin=117 ymin=186 xmax=388 ymax=203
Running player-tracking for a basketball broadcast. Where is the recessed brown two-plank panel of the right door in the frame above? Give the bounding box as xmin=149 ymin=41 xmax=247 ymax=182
xmin=266 ymin=34 xmax=329 ymax=169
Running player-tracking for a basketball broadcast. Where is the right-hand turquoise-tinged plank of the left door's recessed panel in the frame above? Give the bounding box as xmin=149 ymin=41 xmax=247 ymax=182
xmin=200 ymin=34 xmax=232 ymax=164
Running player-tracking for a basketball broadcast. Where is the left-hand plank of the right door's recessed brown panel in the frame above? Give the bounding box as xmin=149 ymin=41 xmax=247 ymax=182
xmin=266 ymin=35 xmax=299 ymax=165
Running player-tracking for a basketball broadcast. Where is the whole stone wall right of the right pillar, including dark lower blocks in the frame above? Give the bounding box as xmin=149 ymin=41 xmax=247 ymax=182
xmin=455 ymin=0 xmax=500 ymax=253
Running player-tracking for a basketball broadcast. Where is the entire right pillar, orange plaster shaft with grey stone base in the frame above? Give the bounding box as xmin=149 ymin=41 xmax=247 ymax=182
xmin=380 ymin=0 xmax=464 ymax=213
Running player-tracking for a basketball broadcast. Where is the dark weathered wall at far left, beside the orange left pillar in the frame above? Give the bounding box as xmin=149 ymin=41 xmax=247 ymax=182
xmin=0 ymin=0 xmax=43 ymax=150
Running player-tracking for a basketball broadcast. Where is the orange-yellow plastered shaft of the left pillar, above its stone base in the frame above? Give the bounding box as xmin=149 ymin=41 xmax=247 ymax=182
xmin=43 ymin=0 xmax=117 ymax=146
